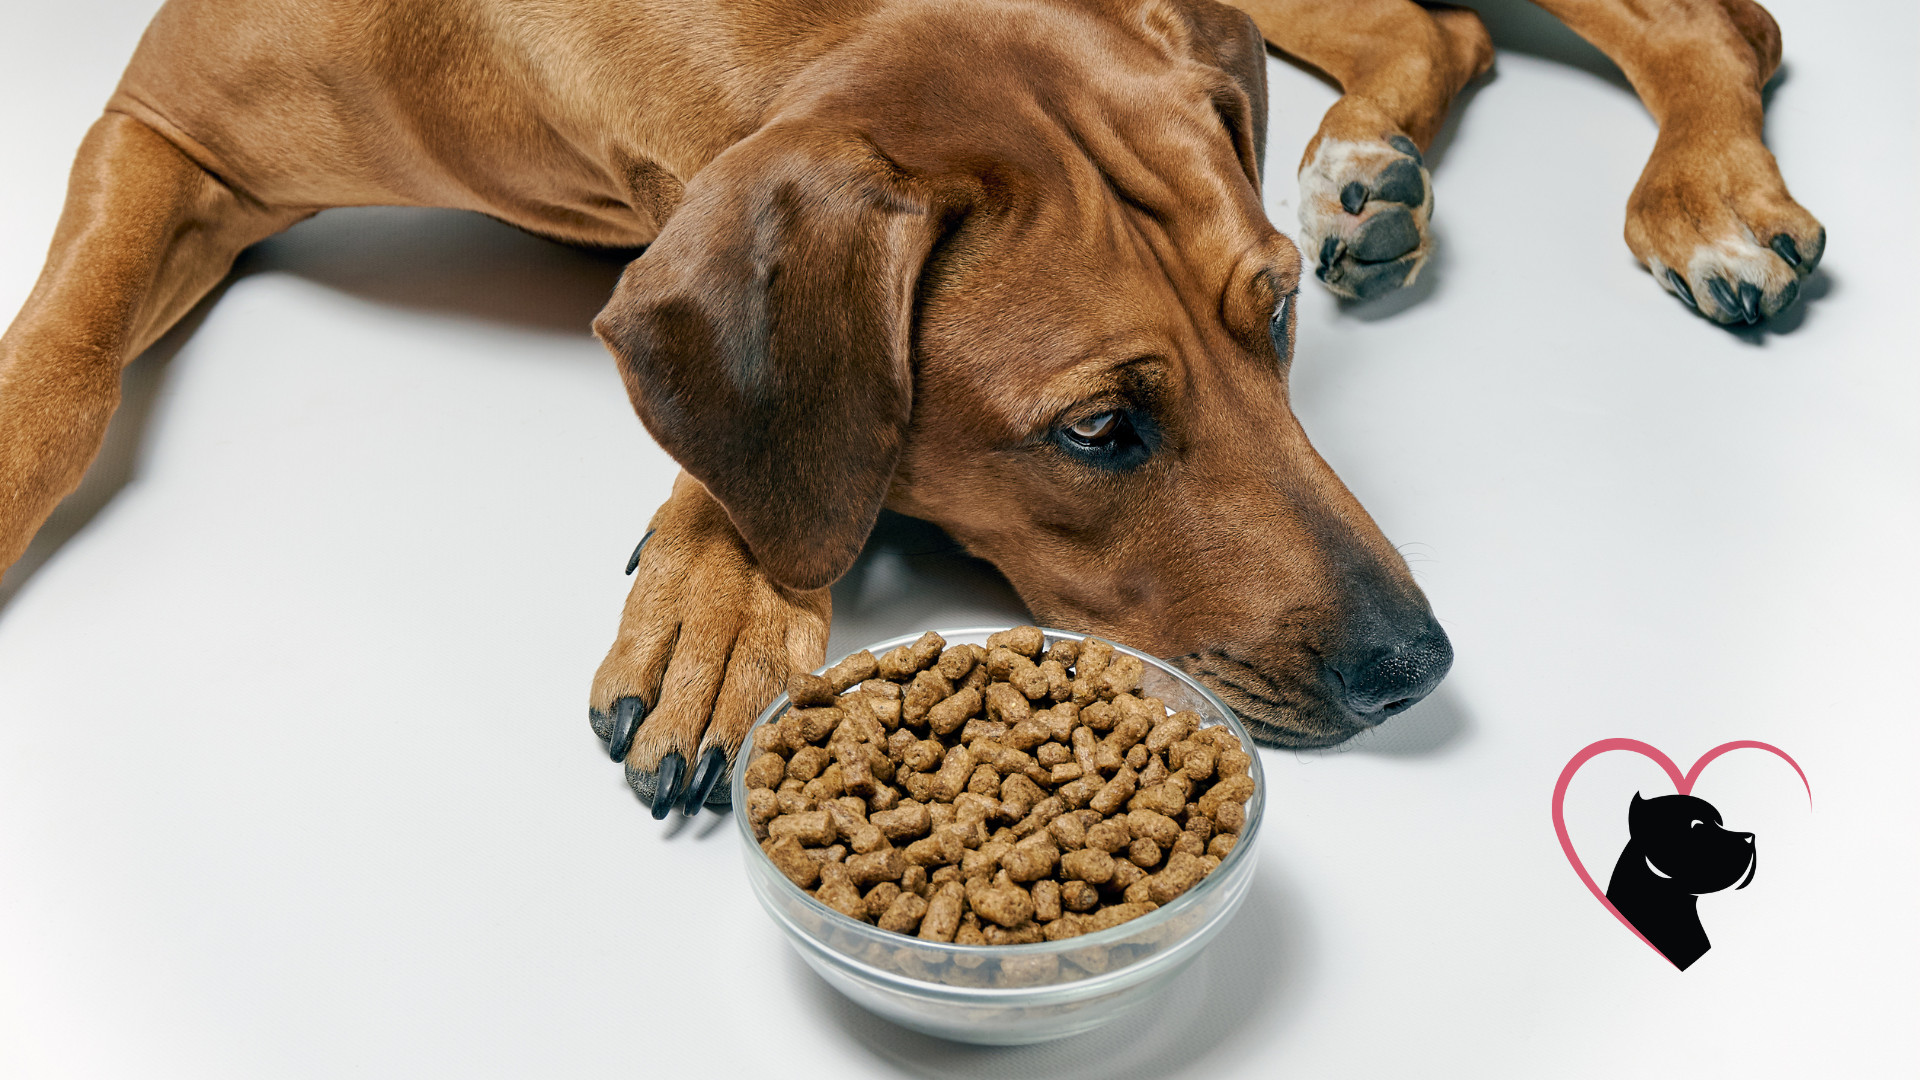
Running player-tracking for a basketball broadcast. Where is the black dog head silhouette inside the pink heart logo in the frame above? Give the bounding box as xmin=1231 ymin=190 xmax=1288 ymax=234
xmin=1607 ymin=792 xmax=1759 ymax=970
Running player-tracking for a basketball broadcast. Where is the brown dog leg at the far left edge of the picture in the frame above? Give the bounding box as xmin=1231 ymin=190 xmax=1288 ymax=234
xmin=0 ymin=113 xmax=300 ymax=573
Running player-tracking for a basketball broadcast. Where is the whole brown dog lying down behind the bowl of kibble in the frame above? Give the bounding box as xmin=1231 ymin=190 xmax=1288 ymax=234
xmin=0 ymin=0 xmax=1824 ymax=815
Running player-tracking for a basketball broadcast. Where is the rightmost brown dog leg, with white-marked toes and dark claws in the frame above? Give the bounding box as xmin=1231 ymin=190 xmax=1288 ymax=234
xmin=1534 ymin=0 xmax=1826 ymax=323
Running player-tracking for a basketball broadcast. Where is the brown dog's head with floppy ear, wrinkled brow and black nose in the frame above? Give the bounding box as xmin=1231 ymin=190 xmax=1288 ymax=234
xmin=595 ymin=0 xmax=1452 ymax=746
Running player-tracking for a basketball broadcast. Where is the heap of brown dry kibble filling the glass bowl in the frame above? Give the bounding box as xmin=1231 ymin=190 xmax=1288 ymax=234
xmin=764 ymin=626 xmax=1254 ymax=953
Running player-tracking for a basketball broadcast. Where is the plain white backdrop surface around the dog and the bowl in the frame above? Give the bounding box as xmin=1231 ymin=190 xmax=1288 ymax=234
xmin=0 ymin=0 xmax=1920 ymax=1080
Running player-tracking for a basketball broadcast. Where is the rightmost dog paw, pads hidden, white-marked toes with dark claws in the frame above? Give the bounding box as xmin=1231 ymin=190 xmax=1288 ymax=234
xmin=1626 ymin=136 xmax=1826 ymax=325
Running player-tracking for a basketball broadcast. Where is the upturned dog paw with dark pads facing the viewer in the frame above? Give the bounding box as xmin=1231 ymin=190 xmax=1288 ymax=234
xmin=1300 ymin=135 xmax=1434 ymax=300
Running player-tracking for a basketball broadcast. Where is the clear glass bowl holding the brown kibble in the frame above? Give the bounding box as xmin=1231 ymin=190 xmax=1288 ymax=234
xmin=732 ymin=626 xmax=1267 ymax=1045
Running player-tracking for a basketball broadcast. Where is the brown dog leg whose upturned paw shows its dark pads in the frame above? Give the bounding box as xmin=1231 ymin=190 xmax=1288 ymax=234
xmin=1233 ymin=0 xmax=1494 ymax=300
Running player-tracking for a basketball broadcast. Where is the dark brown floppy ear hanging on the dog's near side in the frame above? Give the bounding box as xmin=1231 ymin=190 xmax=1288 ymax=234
xmin=593 ymin=125 xmax=958 ymax=588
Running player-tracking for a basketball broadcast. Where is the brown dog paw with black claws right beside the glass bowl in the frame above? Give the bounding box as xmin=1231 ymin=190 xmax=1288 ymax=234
xmin=588 ymin=475 xmax=831 ymax=817
